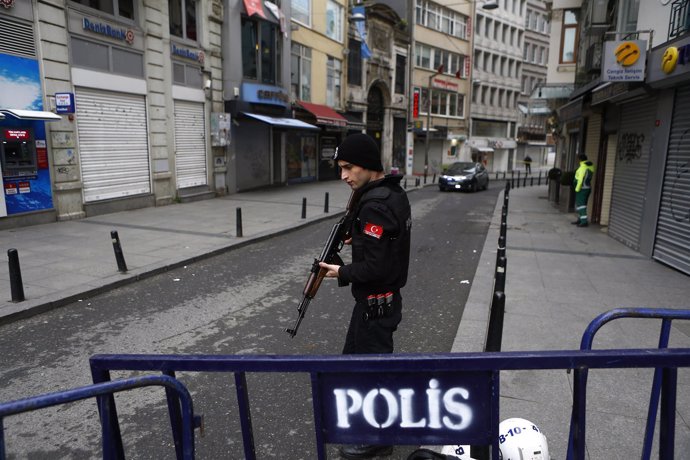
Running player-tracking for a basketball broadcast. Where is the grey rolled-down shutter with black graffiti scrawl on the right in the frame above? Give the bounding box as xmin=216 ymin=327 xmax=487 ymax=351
xmin=609 ymin=99 xmax=656 ymax=251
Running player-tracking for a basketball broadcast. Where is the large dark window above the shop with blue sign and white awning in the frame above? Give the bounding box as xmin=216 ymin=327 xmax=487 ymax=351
xmin=242 ymin=16 xmax=282 ymax=85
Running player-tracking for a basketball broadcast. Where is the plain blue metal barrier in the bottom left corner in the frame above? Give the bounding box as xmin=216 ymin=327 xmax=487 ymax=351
xmin=0 ymin=375 xmax=194 ymax=460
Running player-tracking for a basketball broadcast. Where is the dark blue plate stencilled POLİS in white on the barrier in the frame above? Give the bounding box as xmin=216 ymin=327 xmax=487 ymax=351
xmin=315 ymin=372 xmax=498 ymax=445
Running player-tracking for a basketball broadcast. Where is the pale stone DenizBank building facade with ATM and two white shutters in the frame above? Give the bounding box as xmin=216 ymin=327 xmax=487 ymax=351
xmin=0 ymin=0 xmax=222 ymax=226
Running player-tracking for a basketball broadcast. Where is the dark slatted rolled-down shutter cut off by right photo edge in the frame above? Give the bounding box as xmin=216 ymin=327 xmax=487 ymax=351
xmin=653 ymin=86 xmax=690 ymax=274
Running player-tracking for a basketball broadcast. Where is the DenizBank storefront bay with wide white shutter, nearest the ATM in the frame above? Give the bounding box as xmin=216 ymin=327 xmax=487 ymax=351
xmin=68 ymin=9 xmax=154 ymax=206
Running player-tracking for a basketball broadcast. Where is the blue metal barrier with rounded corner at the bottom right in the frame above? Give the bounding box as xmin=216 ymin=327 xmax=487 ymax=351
xmin=568 ymin=308 xmax=690 ymax=460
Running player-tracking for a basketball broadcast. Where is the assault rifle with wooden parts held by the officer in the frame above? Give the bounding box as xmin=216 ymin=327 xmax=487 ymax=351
xmin=285 ymin=191 xmax=359 ymax=337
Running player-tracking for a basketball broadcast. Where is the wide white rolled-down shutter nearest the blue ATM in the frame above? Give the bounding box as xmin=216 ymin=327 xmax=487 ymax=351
xmin=75 ymin=88 xmax=151 ymax=202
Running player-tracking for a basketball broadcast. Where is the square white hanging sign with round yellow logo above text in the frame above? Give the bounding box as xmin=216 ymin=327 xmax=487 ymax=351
xmin=601 ymin=40 xmax=647 ymax=82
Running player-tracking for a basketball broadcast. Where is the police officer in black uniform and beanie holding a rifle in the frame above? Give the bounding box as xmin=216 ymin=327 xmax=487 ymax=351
xmin=321 ymin=134 xmax=412 ymax=459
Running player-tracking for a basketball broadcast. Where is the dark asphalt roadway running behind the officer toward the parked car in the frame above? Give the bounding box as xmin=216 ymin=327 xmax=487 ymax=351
xmin=0 ymin=186 xmax=499 ymax=459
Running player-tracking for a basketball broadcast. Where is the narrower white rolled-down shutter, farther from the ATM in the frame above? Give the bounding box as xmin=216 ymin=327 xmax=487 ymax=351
xmin=175 ymin=101 xmax=207 ymax=188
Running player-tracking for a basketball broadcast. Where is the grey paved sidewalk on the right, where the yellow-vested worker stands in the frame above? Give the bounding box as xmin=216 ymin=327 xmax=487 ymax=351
xmin=452 ymin=186 xmax=690 ymax=459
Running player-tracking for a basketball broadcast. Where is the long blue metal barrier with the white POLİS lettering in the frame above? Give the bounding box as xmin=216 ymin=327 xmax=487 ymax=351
xmin=90 ymin=349 xmax=690 ymax=460
